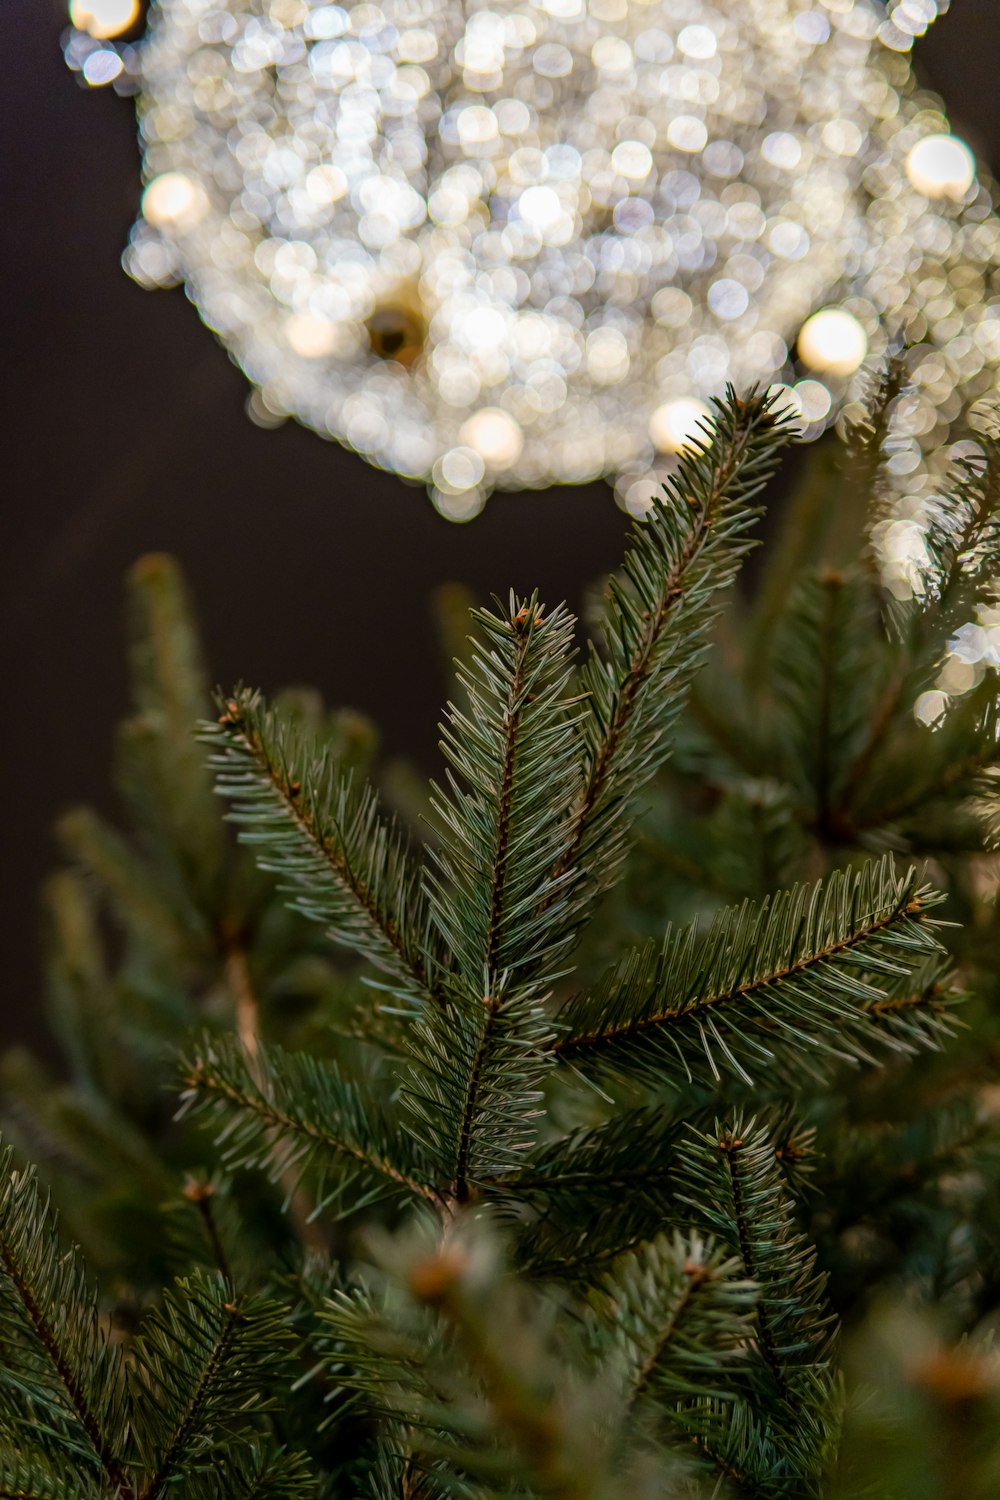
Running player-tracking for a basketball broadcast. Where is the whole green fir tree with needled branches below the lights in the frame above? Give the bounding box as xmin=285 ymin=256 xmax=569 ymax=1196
xmin=0 ymin=390 xmax=1000 ymax=1500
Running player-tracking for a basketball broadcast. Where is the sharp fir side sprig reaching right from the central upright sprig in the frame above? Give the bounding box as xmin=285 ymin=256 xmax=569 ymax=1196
xmin=553 ymin=858 xmax=940 ymax=1082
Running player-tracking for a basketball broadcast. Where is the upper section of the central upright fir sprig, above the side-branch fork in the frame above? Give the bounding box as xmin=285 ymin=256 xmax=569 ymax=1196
xmin=427 ymin=594 xmax=582 ymax=1001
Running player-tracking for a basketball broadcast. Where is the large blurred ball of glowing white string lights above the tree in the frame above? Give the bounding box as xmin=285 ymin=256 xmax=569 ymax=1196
xmin=66 ymin=0 xmax=1000 ymax=522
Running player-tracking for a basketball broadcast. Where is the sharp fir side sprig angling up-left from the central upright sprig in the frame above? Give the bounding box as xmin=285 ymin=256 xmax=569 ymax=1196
xmin=202 ymin=689 xmax=441 ymax=1005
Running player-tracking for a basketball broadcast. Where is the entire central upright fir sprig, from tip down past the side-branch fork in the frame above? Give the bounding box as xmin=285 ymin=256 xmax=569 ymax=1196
xmin=403 ymin=594 xmax=579 ymax=1203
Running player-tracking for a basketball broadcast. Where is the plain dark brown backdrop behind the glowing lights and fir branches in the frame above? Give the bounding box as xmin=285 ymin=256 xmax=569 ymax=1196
xmin=0 ymin=0 xmax=1000 ymax=1044
